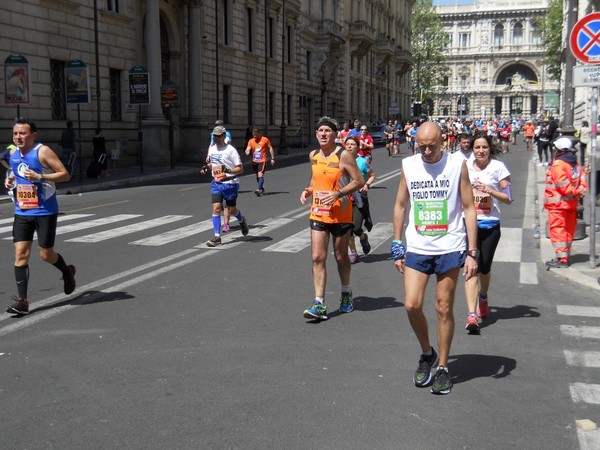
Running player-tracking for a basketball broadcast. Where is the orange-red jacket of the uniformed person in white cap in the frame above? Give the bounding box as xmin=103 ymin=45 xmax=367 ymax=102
xmin=544 ymin=159 xmax=588 ymax=210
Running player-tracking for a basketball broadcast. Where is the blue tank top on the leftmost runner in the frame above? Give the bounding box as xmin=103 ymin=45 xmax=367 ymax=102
xmin=10 ymin=144 xmax=58 ymax=216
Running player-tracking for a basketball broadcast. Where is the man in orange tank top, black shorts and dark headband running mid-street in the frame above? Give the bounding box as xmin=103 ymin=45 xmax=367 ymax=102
xmin=300 ymin=117 xmax=364 ymax=320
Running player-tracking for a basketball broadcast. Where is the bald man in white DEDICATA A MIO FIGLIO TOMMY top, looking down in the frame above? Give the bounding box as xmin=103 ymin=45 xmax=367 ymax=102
xmin=391 ymin=122 xmax=479 ymax=394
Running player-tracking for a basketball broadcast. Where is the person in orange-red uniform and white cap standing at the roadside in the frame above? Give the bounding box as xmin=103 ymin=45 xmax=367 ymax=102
xmin=544 ymin=136 xmax=588 ymax=269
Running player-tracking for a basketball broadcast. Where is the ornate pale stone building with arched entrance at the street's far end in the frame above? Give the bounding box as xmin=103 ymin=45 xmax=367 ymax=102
xmin=430 ymin=0 xmax=559 ymax=119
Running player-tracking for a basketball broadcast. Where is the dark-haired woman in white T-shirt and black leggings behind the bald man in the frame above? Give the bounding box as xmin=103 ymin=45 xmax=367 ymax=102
xmin=465 ymin=132 xmax=512 ymax=333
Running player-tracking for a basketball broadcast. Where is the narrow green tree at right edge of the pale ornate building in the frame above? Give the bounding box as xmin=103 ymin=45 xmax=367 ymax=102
xmin=536 ymin=0 xmax=563 ymax=80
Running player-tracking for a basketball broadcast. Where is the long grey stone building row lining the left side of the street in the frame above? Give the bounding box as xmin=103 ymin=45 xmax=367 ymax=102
xmin=0 ymin=0 xmax=412 ymax=165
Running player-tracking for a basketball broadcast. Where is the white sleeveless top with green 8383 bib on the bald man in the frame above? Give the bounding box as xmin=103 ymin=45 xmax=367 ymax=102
xmin=402 ymin=152 xmax=467 ymax=255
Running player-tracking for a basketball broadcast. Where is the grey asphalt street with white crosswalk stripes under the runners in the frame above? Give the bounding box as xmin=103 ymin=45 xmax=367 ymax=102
xmin=0 ymin=143 xmax=600 ymax=450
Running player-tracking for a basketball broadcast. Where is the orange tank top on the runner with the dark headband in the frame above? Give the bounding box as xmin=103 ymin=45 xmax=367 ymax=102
xmin=310 ymin=147 xmax=352 ymax=223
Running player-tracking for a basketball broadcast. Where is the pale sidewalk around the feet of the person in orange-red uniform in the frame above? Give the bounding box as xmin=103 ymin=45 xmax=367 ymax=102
xmin=530 ymin=161 xmax=600 ymax=291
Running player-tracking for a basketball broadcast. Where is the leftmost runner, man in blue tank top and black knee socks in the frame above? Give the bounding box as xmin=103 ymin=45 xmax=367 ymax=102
xmin=4 ymin=119 xmax=75 ymax=316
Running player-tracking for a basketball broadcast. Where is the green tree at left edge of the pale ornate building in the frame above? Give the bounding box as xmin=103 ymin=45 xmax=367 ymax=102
xmin=411 ymin=0 xmax=448 ymax=110
